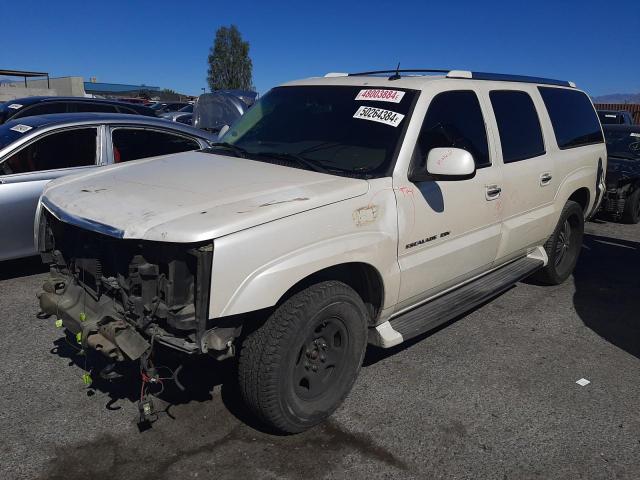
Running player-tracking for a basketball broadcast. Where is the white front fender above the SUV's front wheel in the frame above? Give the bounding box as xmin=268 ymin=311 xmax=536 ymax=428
xmin=209 ymin=179 xmax=400 ymax=318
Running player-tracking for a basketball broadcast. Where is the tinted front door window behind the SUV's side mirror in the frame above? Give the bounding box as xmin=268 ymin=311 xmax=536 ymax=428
xmin=414 ymin=90 xmax=491 ymax=168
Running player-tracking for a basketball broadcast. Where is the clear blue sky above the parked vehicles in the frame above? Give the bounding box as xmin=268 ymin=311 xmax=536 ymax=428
xmin=0 ymin=0 xmax=640 ymax=95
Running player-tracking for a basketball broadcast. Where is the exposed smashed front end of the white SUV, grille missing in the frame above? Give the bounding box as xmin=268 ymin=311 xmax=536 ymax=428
xmin=37 ymin=208 xmax=215 ymax=361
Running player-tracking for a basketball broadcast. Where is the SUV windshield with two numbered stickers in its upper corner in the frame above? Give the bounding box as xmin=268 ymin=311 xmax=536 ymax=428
xmin=221 ymin=86 xmax=417 ymax=178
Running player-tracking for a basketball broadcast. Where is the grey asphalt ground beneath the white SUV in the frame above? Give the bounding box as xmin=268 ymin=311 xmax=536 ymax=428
xmin=0 ymin=218 xmax=640 ymax=480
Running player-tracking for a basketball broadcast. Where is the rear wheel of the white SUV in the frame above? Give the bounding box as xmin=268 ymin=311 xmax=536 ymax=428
xmin=536 ymin=200 xmax=584 ymax=285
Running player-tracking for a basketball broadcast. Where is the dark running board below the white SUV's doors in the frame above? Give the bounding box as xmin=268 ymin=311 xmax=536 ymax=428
xmin=385 ymin=255 xmax=546 ymax=344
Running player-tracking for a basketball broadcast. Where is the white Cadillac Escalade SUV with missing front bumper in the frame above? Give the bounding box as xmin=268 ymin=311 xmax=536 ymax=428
xmin=36 ymin=71 xmax=606 ymax=432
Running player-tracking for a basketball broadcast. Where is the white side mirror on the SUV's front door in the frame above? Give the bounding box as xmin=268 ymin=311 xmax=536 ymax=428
xmin=409 ymin=147 xmax=476 ymax=182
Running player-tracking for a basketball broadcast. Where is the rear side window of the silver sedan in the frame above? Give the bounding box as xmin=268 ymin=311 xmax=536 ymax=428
xmin=111 ymin=128 xmax=200 ymax=163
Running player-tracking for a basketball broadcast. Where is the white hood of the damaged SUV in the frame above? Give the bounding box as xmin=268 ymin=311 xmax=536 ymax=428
xmin=42 ymin=152 xmax=369 ymax=242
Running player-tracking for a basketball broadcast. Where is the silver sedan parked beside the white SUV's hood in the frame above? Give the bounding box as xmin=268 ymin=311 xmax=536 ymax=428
xmin=0 ymin=113 xmax=216 ymax=261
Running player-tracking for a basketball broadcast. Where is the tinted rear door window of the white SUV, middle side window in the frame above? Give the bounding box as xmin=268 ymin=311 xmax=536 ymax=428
xmin=489 ymin=90 xmax=544 ymax=163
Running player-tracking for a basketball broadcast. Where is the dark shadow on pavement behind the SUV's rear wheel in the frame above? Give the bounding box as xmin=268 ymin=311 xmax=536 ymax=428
xmin=573 ymin=234 xmax=640 ymax=358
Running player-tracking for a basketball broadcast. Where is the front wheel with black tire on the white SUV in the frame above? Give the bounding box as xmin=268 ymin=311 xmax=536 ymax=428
xmin=238 ymin=281 xmax=368 ymax=433
